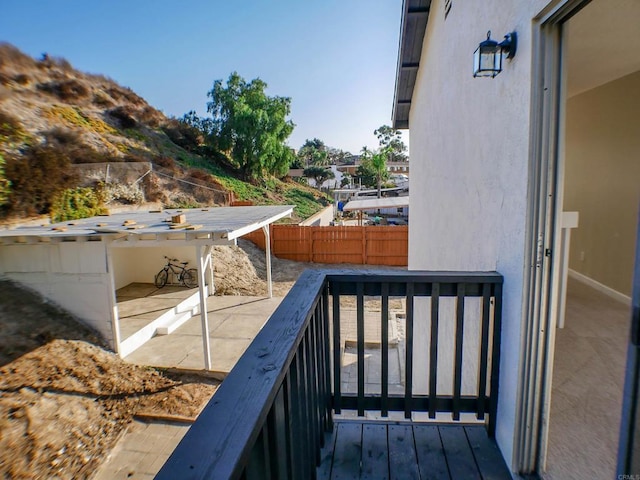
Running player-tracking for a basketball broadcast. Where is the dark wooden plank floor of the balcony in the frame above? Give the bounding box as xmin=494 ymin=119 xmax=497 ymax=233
xmin=317 ymin=420 xmax=511 ymax=480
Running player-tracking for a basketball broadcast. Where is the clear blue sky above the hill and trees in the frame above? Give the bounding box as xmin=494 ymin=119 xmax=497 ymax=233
xmin=0 ymin=0 xmax=408 ymax=153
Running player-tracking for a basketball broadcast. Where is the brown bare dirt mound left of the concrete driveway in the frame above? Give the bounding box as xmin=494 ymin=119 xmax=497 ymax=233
xmin=0 ymin=281 xmax=218 ymax=478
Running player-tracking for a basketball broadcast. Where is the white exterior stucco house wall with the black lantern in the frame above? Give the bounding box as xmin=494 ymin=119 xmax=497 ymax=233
xmin=409 ymin=0 xmax=548 ymax=462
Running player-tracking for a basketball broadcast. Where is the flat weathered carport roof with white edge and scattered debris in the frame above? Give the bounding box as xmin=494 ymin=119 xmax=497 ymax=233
xmin=0 ymin=205 xmax=294 ymax=242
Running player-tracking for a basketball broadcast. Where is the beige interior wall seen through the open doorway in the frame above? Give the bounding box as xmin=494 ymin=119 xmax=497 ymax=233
xmin=564 ymin=72 xmax=640 ymax=296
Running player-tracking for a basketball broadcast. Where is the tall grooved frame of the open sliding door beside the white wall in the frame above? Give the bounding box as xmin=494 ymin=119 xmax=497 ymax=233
xmin=513 ymin=0 xmax=591 ymax=474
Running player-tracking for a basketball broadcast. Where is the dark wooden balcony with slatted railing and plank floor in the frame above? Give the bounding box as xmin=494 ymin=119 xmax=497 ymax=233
xmin=156 ymin=270 xmax=511 ymax=479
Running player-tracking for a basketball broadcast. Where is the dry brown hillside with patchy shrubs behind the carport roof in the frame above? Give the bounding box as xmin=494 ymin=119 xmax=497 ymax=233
xmin=0 ymin=43 xmax=328 ymax=222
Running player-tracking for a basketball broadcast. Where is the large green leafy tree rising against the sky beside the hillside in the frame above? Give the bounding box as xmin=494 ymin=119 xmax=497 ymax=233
xmin=207 ymin=72 xmax=295 ymax=181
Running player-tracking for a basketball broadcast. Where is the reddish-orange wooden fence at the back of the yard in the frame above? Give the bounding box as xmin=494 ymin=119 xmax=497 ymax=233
xmin=244 ymin=225 xmax=409 ymax=266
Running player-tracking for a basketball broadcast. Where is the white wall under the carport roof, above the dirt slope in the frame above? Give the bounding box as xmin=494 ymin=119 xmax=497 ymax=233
xmin=0 ymin=242 xmax=114 ymax=347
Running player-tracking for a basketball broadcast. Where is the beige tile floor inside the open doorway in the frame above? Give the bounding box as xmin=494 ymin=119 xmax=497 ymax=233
xmin=544 ymin=279 xmax=630 ymax=480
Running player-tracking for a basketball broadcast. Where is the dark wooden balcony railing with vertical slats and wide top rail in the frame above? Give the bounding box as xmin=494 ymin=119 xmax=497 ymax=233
xmin=156 ymin=270 xmax=502 ymax=479
